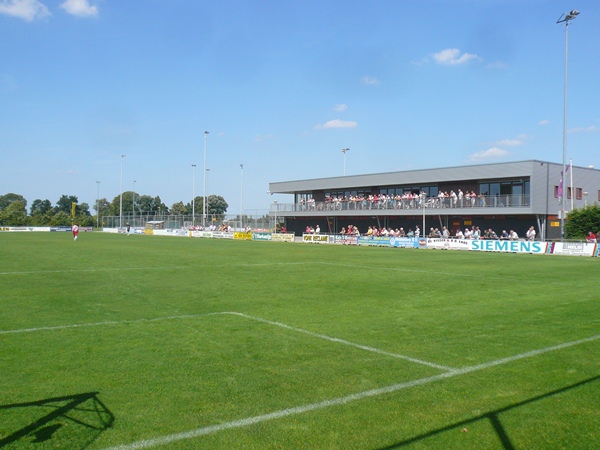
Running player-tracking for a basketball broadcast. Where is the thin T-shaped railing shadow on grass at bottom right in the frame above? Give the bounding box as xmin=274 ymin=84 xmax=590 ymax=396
xmin=378 ymin=375 xmax=600 ymax=450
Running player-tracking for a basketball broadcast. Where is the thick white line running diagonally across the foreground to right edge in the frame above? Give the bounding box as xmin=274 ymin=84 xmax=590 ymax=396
xmin=105 ymin=334 xmax=600 ymax=450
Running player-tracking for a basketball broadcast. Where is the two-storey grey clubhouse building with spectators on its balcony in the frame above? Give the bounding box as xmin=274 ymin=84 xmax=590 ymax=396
xmin=269 ymin=160 xmax=600 ymax=240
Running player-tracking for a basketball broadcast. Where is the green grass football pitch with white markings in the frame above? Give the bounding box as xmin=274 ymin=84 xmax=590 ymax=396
xmin=0 ymin=233 xmax=600 ymax=450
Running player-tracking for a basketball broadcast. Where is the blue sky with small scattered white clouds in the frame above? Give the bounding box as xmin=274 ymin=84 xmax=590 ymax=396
xmin=0 ymin=0 xmax=600 ymax=214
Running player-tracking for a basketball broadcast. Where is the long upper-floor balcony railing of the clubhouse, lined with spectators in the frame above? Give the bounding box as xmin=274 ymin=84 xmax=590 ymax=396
xmin=271 ymin=195 xmax=530 ymax=212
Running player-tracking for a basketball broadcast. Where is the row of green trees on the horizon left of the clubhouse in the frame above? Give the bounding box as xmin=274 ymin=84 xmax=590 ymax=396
xmin=0 ymin=191 xmax=229 ymax=227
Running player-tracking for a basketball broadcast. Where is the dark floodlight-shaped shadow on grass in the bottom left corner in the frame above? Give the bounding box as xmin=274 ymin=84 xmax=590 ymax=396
xmin=0 ymin=392 xmax=115 ymax=449
